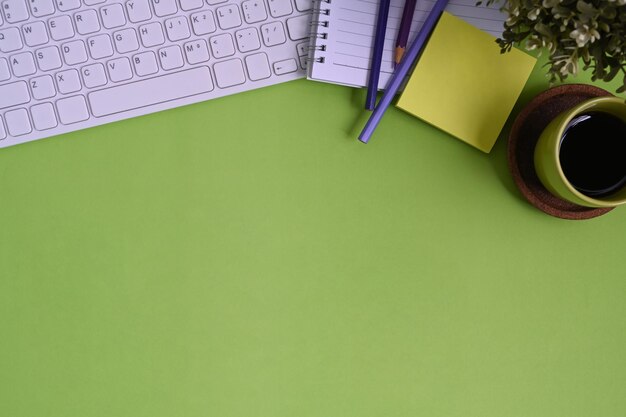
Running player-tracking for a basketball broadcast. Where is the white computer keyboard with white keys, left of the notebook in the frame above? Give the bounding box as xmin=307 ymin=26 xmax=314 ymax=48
xmin=0 ymin=0 xmax=312 ymax=148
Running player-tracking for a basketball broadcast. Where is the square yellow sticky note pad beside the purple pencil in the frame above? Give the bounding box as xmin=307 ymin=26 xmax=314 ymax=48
xmin=397 ymin=12 xmax=536 ymax=153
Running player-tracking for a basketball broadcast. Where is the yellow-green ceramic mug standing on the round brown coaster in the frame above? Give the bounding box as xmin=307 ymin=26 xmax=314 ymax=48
xmin=535 ymin=97 xmax=626 ymax=207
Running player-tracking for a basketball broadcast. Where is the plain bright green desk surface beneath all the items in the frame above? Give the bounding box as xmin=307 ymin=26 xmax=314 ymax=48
xmin=0 ymin=59 xmax=626 ymax=417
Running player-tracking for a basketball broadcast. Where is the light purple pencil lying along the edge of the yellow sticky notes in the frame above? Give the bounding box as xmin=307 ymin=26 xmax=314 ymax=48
xmin=359 ymin=0 xmax=448 ymax=143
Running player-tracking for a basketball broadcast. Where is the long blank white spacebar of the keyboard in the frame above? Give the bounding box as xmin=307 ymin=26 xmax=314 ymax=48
xmin=88 ymin=67 xmax=213 ymax=117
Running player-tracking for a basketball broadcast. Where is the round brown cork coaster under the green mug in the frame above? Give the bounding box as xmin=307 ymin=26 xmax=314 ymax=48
xmin=508 ymin=84 xmax=613 ymax=220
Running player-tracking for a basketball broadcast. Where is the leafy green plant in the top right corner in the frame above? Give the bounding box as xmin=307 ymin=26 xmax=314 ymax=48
xmin=478 ymin=0 xmax=626 ymax=92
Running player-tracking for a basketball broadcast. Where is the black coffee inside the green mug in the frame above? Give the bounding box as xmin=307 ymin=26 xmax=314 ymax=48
xmin=559 ymin=112 xmax=626 ymax=198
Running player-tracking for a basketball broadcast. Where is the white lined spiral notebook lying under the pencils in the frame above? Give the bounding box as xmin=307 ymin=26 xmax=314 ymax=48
xmin=307 ymin=0 xmax=506 ymax=89
